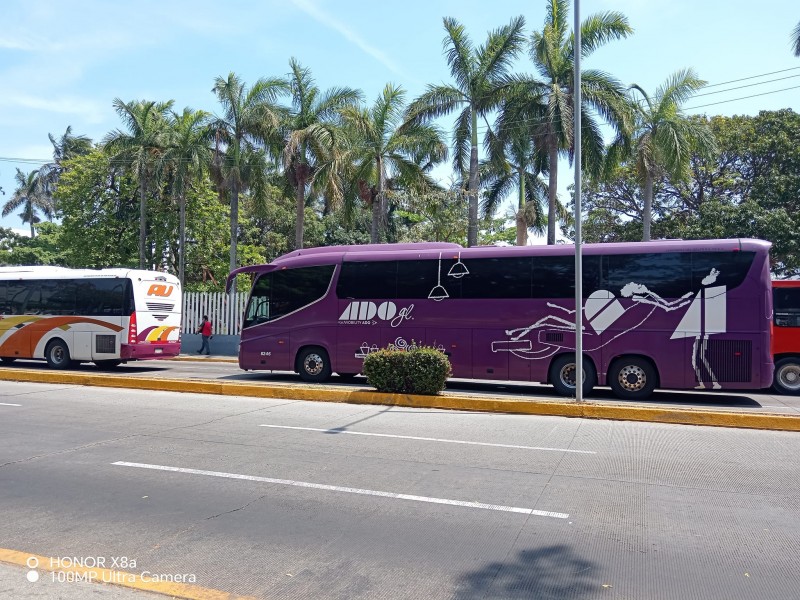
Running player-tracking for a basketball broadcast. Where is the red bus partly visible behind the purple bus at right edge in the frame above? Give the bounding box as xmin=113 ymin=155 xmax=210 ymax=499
xmin=772 ymin=281 xmax=800 ymax=394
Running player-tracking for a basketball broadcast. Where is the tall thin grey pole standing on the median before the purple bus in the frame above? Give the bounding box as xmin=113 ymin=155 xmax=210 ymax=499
xmin=572 ymin=0 xmax=583 ymax=402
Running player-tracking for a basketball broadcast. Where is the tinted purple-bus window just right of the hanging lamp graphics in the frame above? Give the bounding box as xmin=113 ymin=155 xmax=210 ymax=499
xmin=456 ymin=257 xmax=533 ymax=298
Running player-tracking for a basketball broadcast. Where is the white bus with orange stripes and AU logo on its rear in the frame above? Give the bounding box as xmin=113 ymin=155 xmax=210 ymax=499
xmin=0 ymin=266 xmax=182 ymax=369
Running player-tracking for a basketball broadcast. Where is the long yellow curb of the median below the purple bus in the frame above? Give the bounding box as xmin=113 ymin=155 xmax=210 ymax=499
xmin=0 ymin=368 xmax=800 ymax=431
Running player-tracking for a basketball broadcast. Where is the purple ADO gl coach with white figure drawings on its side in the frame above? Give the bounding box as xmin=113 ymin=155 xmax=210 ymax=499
xmin=228 ymin=239 xmax=773 ymax=399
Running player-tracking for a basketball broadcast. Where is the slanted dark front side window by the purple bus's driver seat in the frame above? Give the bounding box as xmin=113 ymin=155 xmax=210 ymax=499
xmin=244 ymin=265 xmax=335 ymax=327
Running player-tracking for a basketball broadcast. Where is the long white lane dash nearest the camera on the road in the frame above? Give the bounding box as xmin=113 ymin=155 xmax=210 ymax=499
xmin=111 ymin=461 xmax=569 ymax=519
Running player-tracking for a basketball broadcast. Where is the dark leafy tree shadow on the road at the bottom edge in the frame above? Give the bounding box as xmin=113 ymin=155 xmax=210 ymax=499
xmin=453 ymin=545 xmax=601 ymax=600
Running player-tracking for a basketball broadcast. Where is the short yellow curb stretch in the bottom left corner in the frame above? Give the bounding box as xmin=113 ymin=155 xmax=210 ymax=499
xmin=0 ymin=548 xmax=255 ymax=600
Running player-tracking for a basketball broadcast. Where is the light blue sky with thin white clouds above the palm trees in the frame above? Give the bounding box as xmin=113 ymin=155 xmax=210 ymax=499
xmin=0 ymin=0 xmax=800 ymax=231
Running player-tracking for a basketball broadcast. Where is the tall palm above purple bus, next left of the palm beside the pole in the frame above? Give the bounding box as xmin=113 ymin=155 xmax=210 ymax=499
xmin=408 ymin=17 xmax=525 ymax=246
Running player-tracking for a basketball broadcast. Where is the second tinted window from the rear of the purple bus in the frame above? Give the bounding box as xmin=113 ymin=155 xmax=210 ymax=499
xmin=603 ymin=252 xmax=692 ymax=298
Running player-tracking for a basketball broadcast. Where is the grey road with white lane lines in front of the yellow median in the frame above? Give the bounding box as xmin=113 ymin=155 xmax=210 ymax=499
xmin=0 ymin=382 xmax=800 ymax=600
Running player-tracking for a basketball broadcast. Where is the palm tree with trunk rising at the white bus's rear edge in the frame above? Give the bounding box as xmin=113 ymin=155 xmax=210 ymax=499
xmin=164 ymin=108 xmax=212 ymax=285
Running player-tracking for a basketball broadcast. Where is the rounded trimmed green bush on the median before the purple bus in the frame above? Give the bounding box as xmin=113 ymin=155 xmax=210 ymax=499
xmin=362 ymin=344 xmax=452 ymax=396
